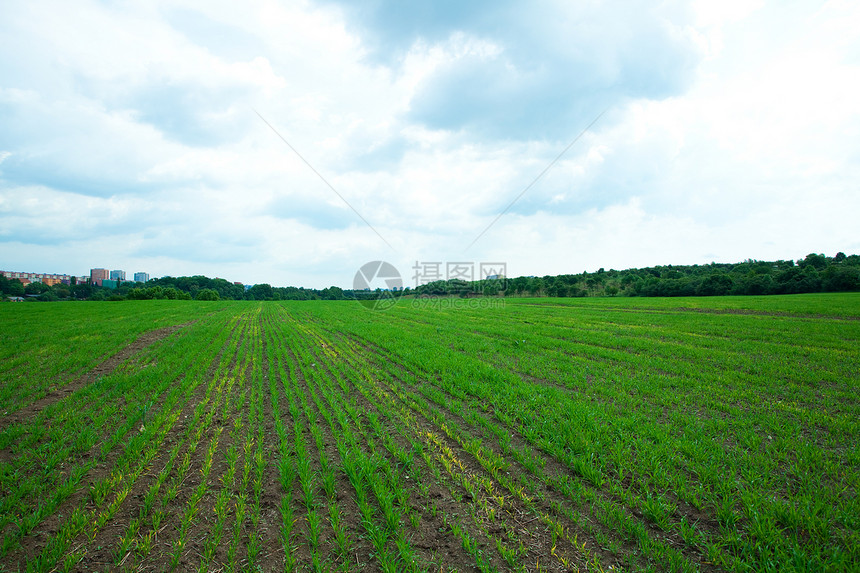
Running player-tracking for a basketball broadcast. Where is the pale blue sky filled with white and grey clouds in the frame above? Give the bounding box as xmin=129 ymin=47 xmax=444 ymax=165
xmin=0 ymin=0 xmax=860 ymax=288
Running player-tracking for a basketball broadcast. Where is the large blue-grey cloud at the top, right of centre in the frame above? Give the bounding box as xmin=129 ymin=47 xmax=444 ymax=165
xmin=326 ymin=2 xmax=703 ymax=139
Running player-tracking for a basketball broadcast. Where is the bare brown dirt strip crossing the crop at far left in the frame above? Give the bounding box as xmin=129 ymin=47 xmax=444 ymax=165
xmin=0 ymin=320 xmax=191 ymax=430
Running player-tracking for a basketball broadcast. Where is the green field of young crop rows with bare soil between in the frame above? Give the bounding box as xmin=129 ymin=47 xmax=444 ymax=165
xmin=0 ymin=294 xmax=860 ymax=572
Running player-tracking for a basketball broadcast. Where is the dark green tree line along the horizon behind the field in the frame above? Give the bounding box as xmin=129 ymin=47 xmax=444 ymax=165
xmin=0 ymin=253 xmax=860 ymax=301
